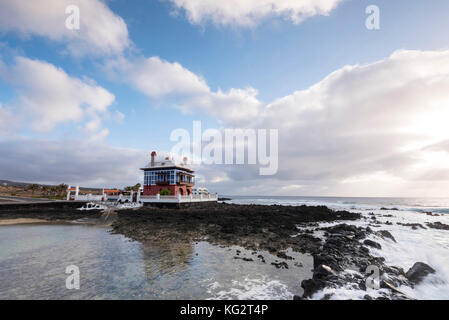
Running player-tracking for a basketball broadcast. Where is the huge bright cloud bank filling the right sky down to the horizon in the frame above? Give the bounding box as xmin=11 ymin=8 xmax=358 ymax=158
xmin=164 ymin=50 xmax=449 ymax=196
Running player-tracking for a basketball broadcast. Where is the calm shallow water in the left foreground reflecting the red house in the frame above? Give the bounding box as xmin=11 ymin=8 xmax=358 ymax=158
xmin=0 ymin=225 xmax=313 ymax=299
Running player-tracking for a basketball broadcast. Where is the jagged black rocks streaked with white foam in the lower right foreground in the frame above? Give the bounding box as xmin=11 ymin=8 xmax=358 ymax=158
xmin=296 ymin=224 xmax=408 ymax=299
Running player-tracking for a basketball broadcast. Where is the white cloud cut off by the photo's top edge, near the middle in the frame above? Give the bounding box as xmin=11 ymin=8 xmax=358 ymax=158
xmin=170 ymin=0 xmax=342 ymax=27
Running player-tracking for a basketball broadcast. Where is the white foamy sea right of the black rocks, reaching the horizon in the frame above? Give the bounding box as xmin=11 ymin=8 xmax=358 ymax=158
xmin=229 ymin=197 xmax=449 ymax=299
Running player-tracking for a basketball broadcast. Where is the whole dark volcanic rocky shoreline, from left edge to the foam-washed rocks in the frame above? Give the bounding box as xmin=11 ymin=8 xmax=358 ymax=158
xmin=0 ymin=203 xmax=434 ymax=300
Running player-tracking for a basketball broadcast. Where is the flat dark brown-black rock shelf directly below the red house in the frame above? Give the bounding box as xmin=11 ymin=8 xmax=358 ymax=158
xmin=113 ymin=203 xmax=360 ymax=255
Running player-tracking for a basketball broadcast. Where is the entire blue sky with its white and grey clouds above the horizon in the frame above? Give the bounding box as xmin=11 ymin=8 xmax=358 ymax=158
xmin=0 ymin=0 xmax=449 ymax=197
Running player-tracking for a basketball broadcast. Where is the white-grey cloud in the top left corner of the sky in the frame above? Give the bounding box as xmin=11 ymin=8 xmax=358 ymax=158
xmin=0 ymin=0 xmax=130 ymax=56
